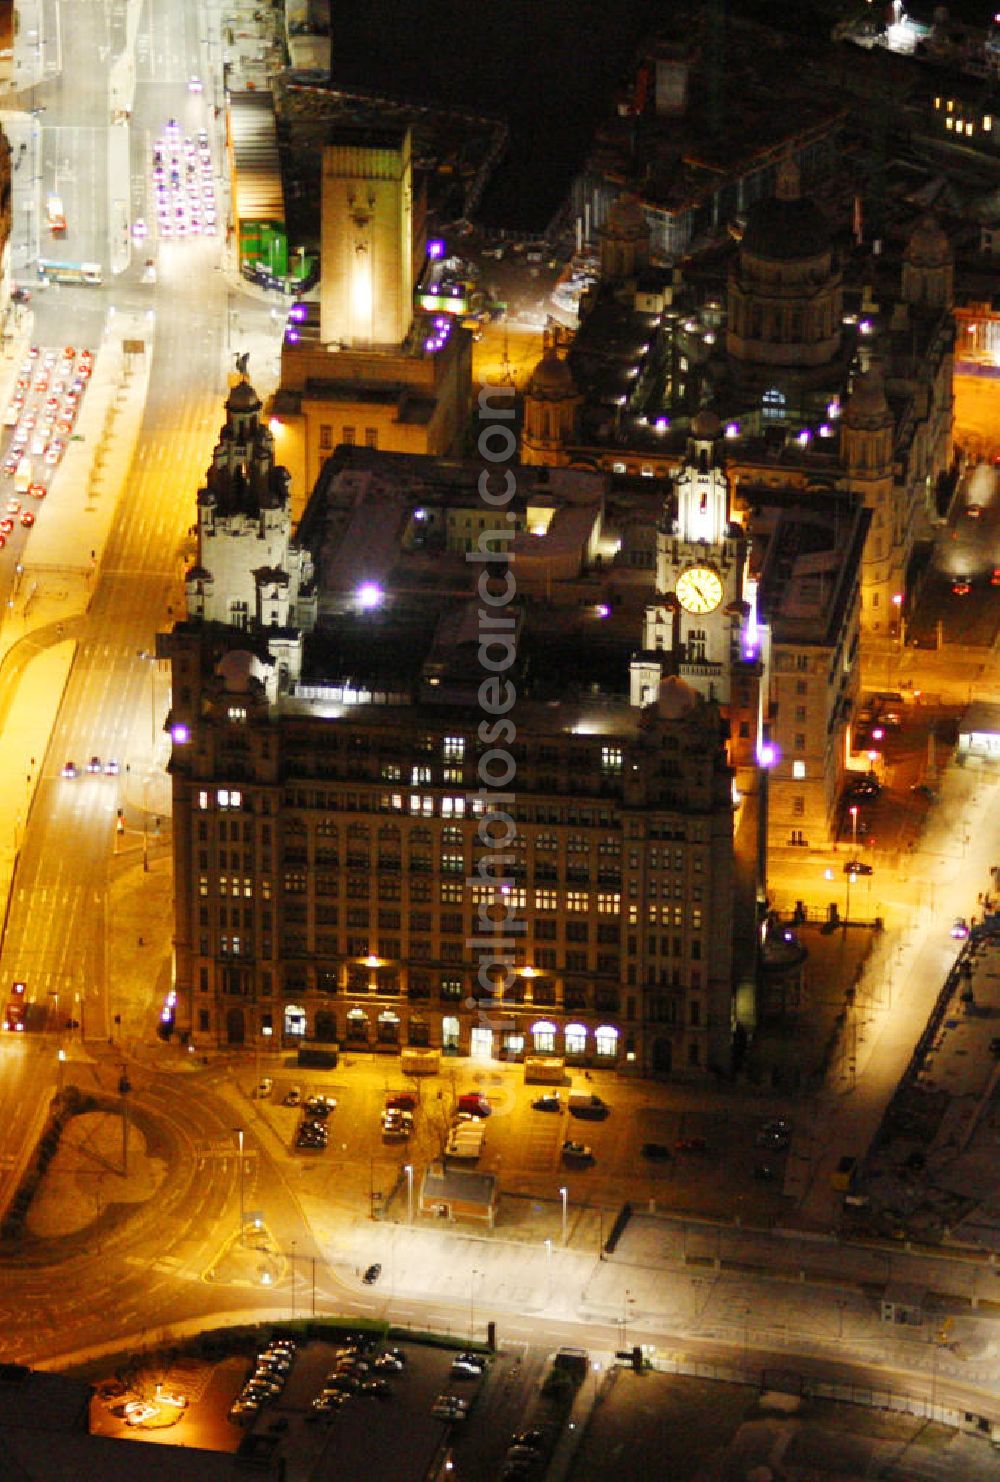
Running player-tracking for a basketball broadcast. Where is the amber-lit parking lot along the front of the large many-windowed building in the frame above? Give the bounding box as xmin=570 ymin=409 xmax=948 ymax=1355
xmin=243 ymin=1057 xmax=805 ymax=1240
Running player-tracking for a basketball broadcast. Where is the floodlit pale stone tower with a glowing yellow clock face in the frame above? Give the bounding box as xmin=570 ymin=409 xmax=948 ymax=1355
xmin=630 ymin=412 xmax=747 ymax=705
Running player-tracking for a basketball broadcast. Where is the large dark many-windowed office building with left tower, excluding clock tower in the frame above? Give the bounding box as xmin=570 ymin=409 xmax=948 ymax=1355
xmin=160 ymin=403 xmax=735 ymax=1076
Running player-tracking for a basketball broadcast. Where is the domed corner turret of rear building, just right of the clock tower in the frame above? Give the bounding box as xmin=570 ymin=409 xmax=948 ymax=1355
xmin=840 ymin=363 xmax=905 ymax=633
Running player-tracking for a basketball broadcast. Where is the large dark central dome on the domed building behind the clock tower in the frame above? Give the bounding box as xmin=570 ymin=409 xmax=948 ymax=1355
xmin=726 ymin=159 xmax=841 ymax=384
